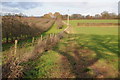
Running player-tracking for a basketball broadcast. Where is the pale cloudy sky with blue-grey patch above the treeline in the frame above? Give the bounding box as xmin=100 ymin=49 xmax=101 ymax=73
xmin=0 ymin=0 xmax=119 ymax=16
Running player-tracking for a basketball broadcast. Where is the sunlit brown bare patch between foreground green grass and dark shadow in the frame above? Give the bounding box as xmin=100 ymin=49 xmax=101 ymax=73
xmin=50 ymin=54 xmax=75 ymax=78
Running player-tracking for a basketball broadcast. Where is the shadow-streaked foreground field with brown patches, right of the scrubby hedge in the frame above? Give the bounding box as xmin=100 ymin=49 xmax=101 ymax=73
xmin=25 ymin=35 xmax=118 ymax=78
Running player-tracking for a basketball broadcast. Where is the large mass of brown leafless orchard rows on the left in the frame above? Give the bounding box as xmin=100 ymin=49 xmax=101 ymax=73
xmin=2 ymin=15 xmax=54 ymax=42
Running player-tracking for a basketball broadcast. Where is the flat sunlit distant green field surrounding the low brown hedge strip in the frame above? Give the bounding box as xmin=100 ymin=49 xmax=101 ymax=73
xmin=66 ymin=20 xmax=118 ymax=35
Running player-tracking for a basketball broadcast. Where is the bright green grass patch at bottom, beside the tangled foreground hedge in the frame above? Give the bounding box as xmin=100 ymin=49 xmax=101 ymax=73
xmin=24 ymin=50 xmax=60 ymax=78
